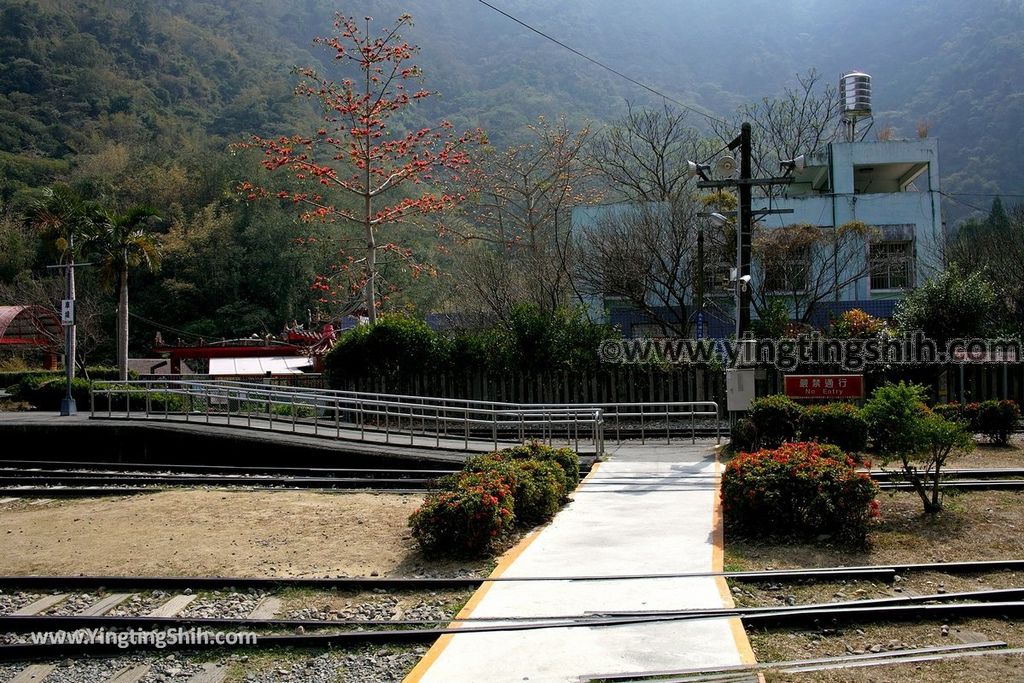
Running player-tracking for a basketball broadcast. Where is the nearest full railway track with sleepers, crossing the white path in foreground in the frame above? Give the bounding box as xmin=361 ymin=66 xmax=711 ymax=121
xmin=0 ymin=560 xmax=1024 ymax=661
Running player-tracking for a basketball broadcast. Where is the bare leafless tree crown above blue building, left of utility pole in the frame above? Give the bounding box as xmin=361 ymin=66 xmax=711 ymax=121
xmin=591 ymin=103 xmax=709 ymax=202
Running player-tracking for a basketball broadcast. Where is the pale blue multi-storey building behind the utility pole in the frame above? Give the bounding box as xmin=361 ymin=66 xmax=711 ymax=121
xmin=572 ymin=138 xmax=943 ymax=337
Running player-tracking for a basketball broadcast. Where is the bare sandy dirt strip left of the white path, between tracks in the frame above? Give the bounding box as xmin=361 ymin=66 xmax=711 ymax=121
xmin=0 ymin=490 xmax=488 ymax=577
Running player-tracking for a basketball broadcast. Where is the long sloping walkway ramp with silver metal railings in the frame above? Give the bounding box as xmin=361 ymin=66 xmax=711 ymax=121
xmin=90 ymin=379 xmax=721 ymax=455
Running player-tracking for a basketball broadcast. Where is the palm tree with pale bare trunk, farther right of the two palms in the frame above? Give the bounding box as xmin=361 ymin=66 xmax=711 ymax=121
xmin=89 ymin=207 xmax=160 ymax=380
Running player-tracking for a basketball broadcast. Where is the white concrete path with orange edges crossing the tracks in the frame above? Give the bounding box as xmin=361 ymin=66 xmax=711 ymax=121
xmin=406 ymin=443 xmax=754 ymax=683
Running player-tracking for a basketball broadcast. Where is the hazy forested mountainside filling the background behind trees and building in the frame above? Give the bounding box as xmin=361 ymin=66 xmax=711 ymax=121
xmin=0 ymin=0 xmax=1024 ymax=358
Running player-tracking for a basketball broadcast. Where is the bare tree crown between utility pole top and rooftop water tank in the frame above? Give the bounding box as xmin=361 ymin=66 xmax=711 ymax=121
xmin=712 ymin=69 xmax=839 ymax=191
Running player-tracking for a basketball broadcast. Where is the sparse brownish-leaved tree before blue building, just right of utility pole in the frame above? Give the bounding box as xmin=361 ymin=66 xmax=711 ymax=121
xmin=753 ymin=221 xmax=878 ymax=323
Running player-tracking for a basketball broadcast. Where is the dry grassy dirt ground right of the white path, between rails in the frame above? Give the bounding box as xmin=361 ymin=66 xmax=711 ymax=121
xmin=725 ymin=491 xmax=1024 ymax=683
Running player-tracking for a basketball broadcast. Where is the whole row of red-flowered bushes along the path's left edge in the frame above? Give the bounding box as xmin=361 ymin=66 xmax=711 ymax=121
xmin=409 ymin=441 xmax=580 ymax=556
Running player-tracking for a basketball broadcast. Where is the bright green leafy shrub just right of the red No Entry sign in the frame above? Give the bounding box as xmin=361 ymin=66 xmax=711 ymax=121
xmin=862 ymin=382 xmax=928 ymax=455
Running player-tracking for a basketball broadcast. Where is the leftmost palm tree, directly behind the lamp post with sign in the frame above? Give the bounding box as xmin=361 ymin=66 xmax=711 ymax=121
xmin=26 ymin=185 xmax=96 ymax=381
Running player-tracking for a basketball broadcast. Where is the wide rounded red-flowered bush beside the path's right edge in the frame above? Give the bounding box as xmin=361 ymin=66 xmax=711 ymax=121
xmin=722 ymin=441 xmax=879 ymax=544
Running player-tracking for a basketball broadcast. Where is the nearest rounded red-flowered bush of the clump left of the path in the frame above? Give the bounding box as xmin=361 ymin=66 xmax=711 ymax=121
xmin=409 ymin=472 xmax=514 ymax=556
